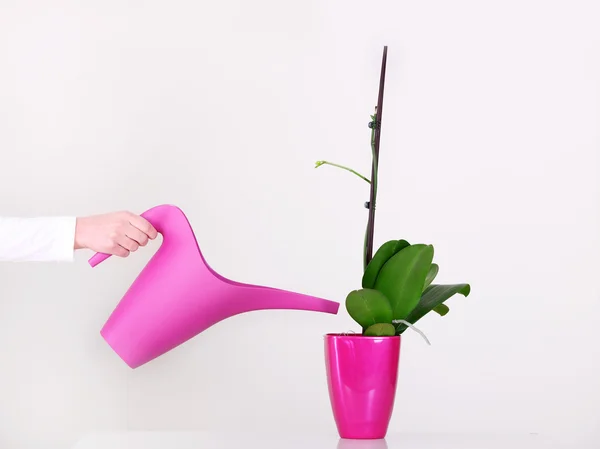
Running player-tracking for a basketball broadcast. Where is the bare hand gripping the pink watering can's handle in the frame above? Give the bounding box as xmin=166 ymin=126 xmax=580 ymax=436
xmin=75 ymin=212 xmax=157 ymax=257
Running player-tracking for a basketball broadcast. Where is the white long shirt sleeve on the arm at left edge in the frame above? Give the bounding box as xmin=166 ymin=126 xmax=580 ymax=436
xmin=0 ymin=217 xmax=76 ymax=262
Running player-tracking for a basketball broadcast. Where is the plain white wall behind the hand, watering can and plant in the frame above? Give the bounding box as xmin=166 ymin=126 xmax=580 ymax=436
xmin=0 ymin=0 xmax=600 ymax=449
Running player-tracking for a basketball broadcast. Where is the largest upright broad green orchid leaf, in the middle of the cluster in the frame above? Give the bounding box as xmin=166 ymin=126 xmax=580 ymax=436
xmin=375 ymin=244 xmax=433 ymax=320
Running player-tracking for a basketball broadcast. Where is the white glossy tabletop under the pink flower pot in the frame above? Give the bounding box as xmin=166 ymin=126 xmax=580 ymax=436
xmin=73 ymin=432 xmax=576 ymax=449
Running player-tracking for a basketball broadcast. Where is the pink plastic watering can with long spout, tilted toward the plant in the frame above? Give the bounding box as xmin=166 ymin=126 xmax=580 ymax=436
xmin=89 ymin=205 xmax=339 ymax=368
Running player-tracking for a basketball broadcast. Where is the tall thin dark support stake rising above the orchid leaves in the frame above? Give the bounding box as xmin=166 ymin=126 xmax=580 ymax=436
xmin=365 ymin=45 xmax=387 ymax=267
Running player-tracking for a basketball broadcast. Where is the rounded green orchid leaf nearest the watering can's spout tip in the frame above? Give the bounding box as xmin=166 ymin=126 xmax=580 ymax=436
xmin=346 ymin=289 xmax=392 ymax=329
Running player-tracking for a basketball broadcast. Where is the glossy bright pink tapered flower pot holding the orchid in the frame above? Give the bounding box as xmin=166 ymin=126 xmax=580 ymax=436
xmin=325 ymin=334 xmax=401 ymax=439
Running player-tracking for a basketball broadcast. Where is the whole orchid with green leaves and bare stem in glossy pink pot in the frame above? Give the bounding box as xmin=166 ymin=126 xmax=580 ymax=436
xmin=316 ymin=47 xmax=471 ymax=439
